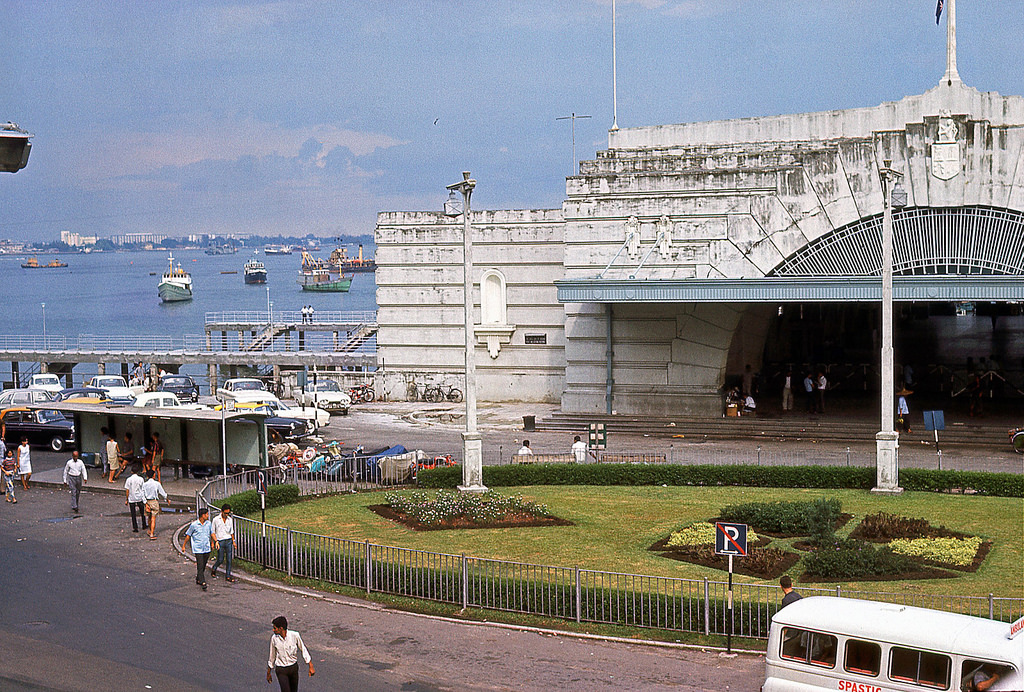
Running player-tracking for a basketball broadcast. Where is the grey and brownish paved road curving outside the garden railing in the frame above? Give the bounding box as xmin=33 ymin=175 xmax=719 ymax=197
xmin=0 ymin=487 xmax=764 ymax=691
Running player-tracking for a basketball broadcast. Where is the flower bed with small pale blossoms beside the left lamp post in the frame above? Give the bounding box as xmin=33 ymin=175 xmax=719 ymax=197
xmin=369 ymin=490 xmax=572 ymax=531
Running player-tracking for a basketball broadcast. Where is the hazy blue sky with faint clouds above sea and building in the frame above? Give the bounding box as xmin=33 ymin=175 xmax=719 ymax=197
xmin=0 ymin=0 xmax=1024 ymax=241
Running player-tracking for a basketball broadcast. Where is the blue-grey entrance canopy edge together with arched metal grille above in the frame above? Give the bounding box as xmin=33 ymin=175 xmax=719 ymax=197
xmin=555 ymin=206 xmax=1024 ymax=303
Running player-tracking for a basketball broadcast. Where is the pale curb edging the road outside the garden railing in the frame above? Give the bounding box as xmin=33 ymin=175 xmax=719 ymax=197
xmin=165 ymin=522 xmax=765 ymax=657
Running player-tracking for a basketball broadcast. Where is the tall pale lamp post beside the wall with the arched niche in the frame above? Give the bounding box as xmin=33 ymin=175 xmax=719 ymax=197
xmin=444 ymin=171 xmax=487 ymax=492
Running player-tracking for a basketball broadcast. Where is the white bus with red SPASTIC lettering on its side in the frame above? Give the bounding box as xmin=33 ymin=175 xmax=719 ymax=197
xmin=761 ymin=596 xmax=1024 ymax=692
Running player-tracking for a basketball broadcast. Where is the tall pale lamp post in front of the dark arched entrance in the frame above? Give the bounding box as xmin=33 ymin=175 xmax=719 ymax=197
xmin=871 ymin=159 xmax=906 ymax=494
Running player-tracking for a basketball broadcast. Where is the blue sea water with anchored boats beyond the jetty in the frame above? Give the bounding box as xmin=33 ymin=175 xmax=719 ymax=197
xmin=0 ymin=248 xmax=377 ymax=384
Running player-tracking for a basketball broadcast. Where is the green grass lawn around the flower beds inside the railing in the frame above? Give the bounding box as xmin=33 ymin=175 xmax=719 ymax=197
xmin=266 ymin=485 xmax=1024 ymax=597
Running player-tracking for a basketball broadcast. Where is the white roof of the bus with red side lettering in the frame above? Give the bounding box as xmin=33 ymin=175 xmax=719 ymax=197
xmin=772 ymin=596 xmax=1024 ymax=669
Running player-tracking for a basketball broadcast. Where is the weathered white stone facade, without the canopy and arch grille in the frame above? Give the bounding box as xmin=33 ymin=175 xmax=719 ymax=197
xmin=377 ymin=79 xmax=1024 ymax=415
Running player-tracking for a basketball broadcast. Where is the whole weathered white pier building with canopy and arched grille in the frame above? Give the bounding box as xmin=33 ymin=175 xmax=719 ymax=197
xmin=376 ymin=14 xmax=1024 ymax=417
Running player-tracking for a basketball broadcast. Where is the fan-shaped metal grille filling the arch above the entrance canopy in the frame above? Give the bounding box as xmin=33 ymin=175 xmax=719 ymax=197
xmin=769 ymin=207 xmax=1024 ymax=276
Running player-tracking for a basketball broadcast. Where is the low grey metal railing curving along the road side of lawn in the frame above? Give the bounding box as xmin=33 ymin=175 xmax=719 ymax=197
xmin=197 ymin=471 xmax=1024 ymax=639
